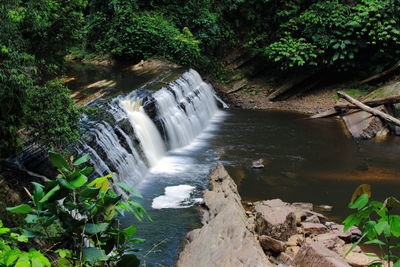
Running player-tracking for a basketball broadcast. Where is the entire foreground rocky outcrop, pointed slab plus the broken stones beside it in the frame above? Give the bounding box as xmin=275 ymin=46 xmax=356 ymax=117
xmin=177 ymin=164 xmax=371 ymax=267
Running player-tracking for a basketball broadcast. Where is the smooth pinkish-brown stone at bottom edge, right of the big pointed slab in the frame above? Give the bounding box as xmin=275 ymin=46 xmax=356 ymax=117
xmin=294 ymin=242 xmax=350 ymax=267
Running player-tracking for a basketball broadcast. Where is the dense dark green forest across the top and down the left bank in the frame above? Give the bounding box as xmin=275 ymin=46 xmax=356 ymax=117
xmin=0 ymin=0 xmax=400 ymax=157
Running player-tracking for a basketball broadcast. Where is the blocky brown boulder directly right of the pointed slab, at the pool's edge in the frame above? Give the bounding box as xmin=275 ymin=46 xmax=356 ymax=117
xmin=254 ymin=199 xmax=297 ymax=241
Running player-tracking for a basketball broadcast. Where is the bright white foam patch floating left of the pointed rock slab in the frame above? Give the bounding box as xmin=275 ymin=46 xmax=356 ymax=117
xmin=151 ymin=184 xmax=195 ymax=209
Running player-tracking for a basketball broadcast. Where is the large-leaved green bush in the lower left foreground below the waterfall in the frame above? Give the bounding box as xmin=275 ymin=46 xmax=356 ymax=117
xmin=5 ymin=152 xmax=150 ymax=266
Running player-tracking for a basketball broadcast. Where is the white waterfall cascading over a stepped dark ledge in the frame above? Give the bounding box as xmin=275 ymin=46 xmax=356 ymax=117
xmin=78 ymin=70 xmax=225 ymax=184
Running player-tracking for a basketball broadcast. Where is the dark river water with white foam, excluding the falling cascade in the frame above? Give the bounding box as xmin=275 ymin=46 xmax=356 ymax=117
xmin=66 ymin=62 xmax=400 ymax=266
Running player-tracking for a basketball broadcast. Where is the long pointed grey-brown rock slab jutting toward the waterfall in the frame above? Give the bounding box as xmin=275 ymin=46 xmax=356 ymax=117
xmin=177 ymin=164 xmax=272 ymax=267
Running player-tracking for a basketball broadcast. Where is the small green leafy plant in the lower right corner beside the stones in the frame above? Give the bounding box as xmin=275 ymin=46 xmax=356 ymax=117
xmin=343 ymin=185 xmax=400 ymax=266
